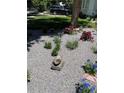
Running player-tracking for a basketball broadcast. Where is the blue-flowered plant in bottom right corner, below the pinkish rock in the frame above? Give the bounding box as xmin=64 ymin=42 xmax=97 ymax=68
xmin=77 ymin=78 xmax=97 ymax=93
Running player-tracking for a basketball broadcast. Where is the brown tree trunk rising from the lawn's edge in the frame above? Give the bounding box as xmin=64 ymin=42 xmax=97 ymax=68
xmin=71 ymin=0 xmax=82 ymax=26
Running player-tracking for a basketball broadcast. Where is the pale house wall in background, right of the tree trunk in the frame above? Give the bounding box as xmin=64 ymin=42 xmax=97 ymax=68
xmin=81 ymin=0 xmax=97 ymax=16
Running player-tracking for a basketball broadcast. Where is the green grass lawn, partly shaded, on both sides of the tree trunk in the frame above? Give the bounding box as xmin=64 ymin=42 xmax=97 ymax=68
xmin=27 ymin=16 xmax=96 ymax=29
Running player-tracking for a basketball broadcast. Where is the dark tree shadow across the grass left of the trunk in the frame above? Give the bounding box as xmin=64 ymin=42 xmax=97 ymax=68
xmin=27 ymin=18 xmax=70 ymax=30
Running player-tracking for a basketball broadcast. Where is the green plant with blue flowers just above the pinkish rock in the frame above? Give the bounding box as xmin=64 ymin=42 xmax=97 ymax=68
xmin=82 ymin=60 xmax=97 ymax=76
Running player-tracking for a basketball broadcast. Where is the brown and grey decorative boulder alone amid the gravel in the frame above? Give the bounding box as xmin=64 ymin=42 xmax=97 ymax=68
xmin=51 ymin=55 xmax=64 ymax=71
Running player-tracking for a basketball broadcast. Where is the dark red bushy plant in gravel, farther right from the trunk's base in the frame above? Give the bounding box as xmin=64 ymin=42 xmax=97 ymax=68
xmin=80 ymin=31 xmax=93 ymax=41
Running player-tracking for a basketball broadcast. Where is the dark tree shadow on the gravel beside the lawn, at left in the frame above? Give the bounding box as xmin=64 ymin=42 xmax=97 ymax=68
xmin=27 ymin=29 xmax=63 ymax=52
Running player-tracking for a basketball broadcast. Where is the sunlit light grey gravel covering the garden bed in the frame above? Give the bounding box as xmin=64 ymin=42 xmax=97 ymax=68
xmin=27 ymin=28 xmax=97 ymax=93
